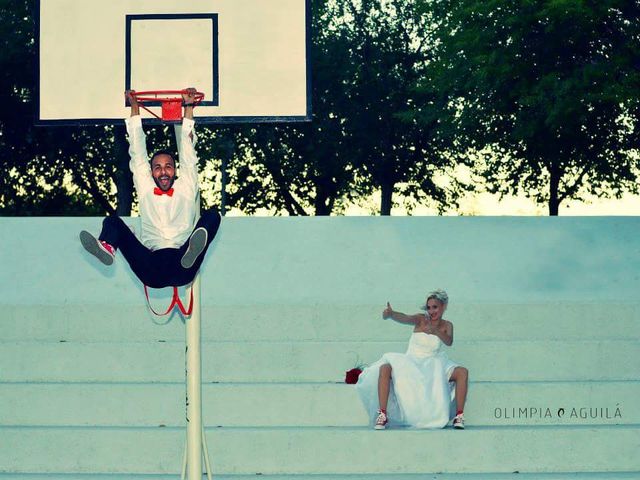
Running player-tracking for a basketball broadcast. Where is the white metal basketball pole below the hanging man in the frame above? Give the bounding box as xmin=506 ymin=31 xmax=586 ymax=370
xmin=186 ymin=273 xmax=203 ymax=480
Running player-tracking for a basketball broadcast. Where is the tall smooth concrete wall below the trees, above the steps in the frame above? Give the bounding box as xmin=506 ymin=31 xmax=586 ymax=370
xmin=0 ymin=217 xmax=640 ymax=307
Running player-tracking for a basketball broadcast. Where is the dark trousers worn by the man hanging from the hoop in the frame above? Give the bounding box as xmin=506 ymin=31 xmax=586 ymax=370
xmin=99 ymin=208 xmax=220 ymax=288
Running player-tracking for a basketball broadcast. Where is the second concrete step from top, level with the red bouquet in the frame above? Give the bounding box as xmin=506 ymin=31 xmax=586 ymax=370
xmin=0 ymin=339 xmax=640 ymax=382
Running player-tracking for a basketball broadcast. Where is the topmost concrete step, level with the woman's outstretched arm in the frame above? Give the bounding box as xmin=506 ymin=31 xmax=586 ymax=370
xmin=0 ymin=302 xmax=640 ymax=342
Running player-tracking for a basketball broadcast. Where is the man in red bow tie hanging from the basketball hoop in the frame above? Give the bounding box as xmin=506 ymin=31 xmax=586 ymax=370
xmin=80 ymin=88 xmax=220 ymax=288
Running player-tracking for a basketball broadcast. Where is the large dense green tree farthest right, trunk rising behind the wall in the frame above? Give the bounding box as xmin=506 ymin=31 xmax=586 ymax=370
xmin=422 ymin=0 xmax=640 ymax=215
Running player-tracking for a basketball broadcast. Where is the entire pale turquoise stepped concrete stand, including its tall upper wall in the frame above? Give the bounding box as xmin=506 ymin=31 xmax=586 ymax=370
xmin=0 ymin=218 xmax=640 ymax=480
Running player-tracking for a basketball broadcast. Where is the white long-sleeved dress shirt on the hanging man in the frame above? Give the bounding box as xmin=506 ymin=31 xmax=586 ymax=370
xmin=125 ymin=115 xmax=198 ymax=250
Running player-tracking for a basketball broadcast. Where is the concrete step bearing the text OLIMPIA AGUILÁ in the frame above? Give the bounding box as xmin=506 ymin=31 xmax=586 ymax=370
xmin=0 ymin=381 xmax=640 ymax=427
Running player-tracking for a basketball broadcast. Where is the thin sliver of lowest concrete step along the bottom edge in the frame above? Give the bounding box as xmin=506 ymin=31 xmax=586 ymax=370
xmin=0 ymin=472 xmax=638 ymax=480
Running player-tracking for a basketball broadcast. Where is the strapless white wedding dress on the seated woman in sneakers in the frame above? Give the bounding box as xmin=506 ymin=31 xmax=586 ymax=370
xmin=356 ymin=332 xmax=458 ymax=428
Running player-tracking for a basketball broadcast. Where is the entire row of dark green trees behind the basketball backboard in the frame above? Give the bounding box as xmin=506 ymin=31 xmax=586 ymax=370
xmin=0 ymin=0 xmax=640 ymax=215
